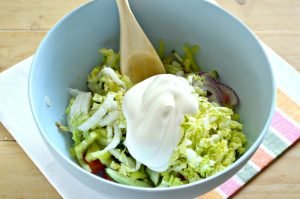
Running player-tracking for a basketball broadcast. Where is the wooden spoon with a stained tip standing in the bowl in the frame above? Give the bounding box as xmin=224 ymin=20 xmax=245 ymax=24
xmin=116 ymin=0 xmax=165 ymax=83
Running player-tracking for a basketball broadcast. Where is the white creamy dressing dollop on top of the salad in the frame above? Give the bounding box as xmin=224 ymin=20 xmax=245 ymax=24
xmin=123 ymin=74 xmax=198 ymax=172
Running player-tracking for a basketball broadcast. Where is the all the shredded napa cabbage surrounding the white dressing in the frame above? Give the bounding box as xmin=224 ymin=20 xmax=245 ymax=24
xmin=56 ymin=45 xmax=246 ymax=187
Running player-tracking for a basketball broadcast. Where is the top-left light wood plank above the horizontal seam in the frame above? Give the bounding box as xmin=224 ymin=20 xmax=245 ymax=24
xmin=0 ymin=0 xmax=87 ymax=30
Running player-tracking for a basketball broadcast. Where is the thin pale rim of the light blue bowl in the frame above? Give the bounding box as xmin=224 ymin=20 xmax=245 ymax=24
xmin=28 ymin=0 xmax=276 ymax=192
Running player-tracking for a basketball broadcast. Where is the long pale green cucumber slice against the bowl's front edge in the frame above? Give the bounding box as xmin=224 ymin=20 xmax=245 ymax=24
xmin=105 ymin=168 xmax=151 ymax=187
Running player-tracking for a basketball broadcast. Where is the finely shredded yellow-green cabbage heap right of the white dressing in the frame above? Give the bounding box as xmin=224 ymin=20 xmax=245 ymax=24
xmin=162 ymin=96 xmax=246 ymax=186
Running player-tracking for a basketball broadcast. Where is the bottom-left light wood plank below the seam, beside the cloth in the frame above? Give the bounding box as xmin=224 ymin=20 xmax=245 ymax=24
xmin=0 ymin=141 xmax=61 ymax=199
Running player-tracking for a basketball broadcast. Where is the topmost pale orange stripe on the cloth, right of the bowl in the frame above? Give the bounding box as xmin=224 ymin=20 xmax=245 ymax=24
xmin=277 ymin=89 xmax=300 ymax=122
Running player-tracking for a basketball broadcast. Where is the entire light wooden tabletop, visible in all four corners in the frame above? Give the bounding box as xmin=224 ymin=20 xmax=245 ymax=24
xmin=0 ymin=0 xmax=300 ymax=199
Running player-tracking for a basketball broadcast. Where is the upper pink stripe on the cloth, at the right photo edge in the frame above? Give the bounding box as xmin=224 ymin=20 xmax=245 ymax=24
xmin=271 ymin=111 xmax=300 ymax=143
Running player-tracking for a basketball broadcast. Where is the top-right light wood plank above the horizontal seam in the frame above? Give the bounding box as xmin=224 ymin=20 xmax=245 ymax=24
xmin=216 ymin=0 xmax=300 ymax=32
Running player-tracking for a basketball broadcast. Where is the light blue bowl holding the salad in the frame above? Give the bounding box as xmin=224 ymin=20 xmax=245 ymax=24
xmin=29 ymin=0 xmax=275 ymax=198
